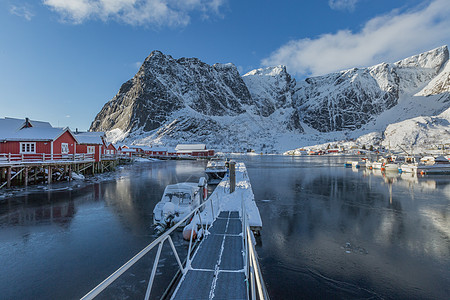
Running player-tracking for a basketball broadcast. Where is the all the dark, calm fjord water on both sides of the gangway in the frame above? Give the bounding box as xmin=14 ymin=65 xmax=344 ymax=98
xmin=0 ymin=156 xmax=450 ymax=299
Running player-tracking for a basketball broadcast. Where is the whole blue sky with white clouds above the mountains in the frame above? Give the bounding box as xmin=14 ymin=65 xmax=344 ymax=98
xmin=0 ymin=0 xmax=450 ymax=130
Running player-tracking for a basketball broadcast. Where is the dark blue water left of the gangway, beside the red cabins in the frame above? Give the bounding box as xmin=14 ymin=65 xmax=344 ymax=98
xmin=0 ymin=161 xmax=205 ymax=299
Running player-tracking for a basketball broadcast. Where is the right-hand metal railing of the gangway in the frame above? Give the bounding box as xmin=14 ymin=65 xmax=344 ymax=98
xmin=241 ymin=188 xmax=270 ymax=300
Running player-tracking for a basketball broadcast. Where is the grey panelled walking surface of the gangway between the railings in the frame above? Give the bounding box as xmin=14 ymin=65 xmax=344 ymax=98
xmin=172 ymin=211 xmax=247 ymax=300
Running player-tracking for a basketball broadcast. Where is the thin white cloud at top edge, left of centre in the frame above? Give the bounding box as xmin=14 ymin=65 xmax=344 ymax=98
xmin=43 ymin=0 xmax=226 ymax=26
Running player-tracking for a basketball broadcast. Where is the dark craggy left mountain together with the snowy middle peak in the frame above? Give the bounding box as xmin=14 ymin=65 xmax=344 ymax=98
xmin=91 ymin=51 xmax=303 ymax=150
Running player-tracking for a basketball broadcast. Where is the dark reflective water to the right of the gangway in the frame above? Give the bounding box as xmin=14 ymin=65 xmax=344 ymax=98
xmin=243 ymin=157 xmax=450 ymax=299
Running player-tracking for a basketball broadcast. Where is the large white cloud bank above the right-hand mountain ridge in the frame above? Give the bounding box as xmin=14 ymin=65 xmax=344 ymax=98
xmin=262 ymin=0 xmax=450 ymax=75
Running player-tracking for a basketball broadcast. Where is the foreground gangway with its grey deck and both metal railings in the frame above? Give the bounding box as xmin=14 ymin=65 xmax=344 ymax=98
xmin=82 ymin=162 xmax=269 ymax=300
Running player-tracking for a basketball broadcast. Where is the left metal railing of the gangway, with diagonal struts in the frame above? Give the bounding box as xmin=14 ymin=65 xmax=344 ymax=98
xmin=81 ymin=197 xmax=214 ymax=300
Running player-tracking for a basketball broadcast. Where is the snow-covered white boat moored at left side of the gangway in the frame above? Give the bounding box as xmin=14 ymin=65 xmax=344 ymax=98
xmin=153 ymin=177 xmax=208 ymax=232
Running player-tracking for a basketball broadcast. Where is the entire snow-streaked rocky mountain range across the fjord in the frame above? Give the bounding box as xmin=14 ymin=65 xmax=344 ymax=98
xmin=91 ymin=46 xmax=450 ymax=152
